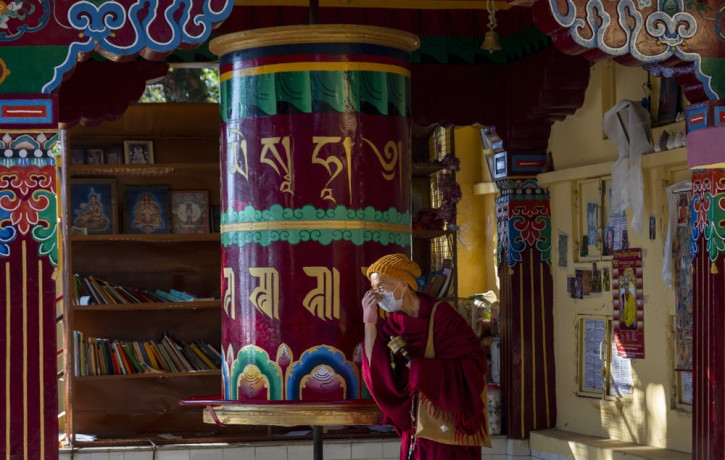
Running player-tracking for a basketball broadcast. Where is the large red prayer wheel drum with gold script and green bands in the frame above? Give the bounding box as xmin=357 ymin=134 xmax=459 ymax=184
xmin=211 ymin=25 xmax=418 ymax=401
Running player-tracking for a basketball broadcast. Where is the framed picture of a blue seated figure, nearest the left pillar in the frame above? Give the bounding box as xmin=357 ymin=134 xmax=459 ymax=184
xmin=69 ymin=179 xmax=118 ymax=235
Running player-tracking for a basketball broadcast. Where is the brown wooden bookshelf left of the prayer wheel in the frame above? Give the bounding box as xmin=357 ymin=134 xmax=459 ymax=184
xmin=60 ymin=104 xmax=232 ymax=445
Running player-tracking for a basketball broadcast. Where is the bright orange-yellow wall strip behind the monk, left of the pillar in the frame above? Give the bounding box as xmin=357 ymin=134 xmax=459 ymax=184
xmin=454 ymin=126 xmax=498 ymax=297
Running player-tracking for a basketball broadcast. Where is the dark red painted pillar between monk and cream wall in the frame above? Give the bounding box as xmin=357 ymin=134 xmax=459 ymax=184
xmin=496 ymin=179 xmax=556 ymax=439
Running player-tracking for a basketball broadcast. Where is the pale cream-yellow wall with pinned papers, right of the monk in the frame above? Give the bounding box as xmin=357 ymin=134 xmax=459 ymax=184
xmin=540 ymin=63 xmax=692 ymax=452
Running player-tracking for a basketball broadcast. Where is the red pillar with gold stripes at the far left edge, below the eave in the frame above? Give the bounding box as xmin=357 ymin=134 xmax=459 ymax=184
xmin=0 ymin=95 xmax=58 ymax=460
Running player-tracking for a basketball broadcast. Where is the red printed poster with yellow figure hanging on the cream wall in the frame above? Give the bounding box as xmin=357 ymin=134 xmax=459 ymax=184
xmin=612 ymin=248 xmax=644 ymax=358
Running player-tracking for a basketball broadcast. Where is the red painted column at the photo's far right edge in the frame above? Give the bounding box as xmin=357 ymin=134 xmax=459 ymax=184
xmin=687 ymin=114 xmax=725 ymax=460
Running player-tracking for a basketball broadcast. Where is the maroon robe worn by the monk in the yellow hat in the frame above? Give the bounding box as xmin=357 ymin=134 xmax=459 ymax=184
xmin=363 ymin=293 xmax=486 ymax=460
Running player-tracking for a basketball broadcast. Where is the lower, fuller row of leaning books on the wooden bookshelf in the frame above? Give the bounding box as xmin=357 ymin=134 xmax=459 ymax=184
xmin=73 ymin=331 xmax=221 ymax=377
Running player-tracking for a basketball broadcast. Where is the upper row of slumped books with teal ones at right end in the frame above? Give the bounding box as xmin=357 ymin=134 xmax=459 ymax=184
xmin=73 ymin=274 xmax=214 ymax=305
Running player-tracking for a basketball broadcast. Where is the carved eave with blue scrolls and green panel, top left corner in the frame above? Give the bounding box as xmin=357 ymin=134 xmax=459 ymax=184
xmin=0 ymin=0 xmax=234 ymax=94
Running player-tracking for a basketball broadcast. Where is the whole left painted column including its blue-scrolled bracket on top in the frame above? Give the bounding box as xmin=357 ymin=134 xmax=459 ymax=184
xmin=0 ymin=0 xmax=233 ymax=452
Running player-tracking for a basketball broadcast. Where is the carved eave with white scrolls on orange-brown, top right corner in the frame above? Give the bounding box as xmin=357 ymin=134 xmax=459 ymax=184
xmin=532 ymin=0 xmax=725 ymax=102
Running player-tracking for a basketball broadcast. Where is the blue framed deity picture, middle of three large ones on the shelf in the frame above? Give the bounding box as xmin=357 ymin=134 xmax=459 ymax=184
xmin=123 ymin=185 xmax=170 ymax=234
